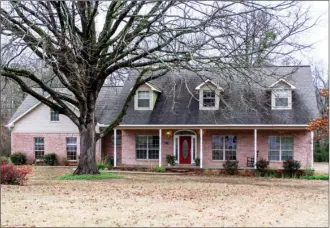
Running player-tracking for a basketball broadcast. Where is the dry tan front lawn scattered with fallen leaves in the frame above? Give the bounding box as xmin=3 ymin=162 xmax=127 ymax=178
xmin=1 ymin=167 xmax=329 ymax=227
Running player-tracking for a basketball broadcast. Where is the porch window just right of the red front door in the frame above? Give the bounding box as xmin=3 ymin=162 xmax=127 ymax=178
xmin=212 ymin=135 xmax=237 ymax=160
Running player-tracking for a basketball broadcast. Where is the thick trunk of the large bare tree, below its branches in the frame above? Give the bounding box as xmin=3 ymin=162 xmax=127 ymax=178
xmin=73 ymin=123 xmax=100 ymax=175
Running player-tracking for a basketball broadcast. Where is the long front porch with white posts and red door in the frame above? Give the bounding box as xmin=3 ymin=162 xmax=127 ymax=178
xmin=102 ymin=127 xmax=313 ymax=169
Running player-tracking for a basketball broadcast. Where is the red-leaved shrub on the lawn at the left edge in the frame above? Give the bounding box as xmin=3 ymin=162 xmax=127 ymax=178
xmin=1 ymin=162 xmax=32 ymax=185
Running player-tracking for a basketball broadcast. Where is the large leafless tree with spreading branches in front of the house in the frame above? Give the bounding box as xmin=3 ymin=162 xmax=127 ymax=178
xmin=0 ymin=0 xmax=313 ymax=174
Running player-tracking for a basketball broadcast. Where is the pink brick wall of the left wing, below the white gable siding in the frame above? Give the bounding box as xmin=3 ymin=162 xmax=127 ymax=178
xmin=11 ymin=133 xmax=100 ymax=165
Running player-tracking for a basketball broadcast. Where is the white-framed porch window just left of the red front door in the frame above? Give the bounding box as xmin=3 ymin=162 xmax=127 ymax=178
xmin=136 ymin=135 xmax=159 ymax=159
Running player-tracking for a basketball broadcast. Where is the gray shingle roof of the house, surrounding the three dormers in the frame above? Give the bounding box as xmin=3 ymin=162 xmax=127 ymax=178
xmin=9 ymin=66 xmax=318 ymax=125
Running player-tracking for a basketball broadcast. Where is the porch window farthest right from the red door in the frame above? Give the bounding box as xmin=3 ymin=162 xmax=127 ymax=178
xmin=268 ymin=136 xmax=293 ymax=161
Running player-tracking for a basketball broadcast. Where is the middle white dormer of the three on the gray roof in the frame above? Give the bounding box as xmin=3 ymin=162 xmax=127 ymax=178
xmin=195 ymin=79 xmax=223 ymax=110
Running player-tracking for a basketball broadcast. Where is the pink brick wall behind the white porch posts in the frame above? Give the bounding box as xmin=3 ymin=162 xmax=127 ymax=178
xmin=121 ymin=129 xmax=311 ymax=168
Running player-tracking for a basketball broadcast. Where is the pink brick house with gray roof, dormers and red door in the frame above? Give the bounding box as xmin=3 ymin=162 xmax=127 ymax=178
xmin=7 ymin=66 xmax=318 ymax=168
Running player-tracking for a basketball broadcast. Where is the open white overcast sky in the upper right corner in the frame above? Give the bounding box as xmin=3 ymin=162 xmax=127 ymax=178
xmin=301 ymin=1 xmax=329 ymax=68
